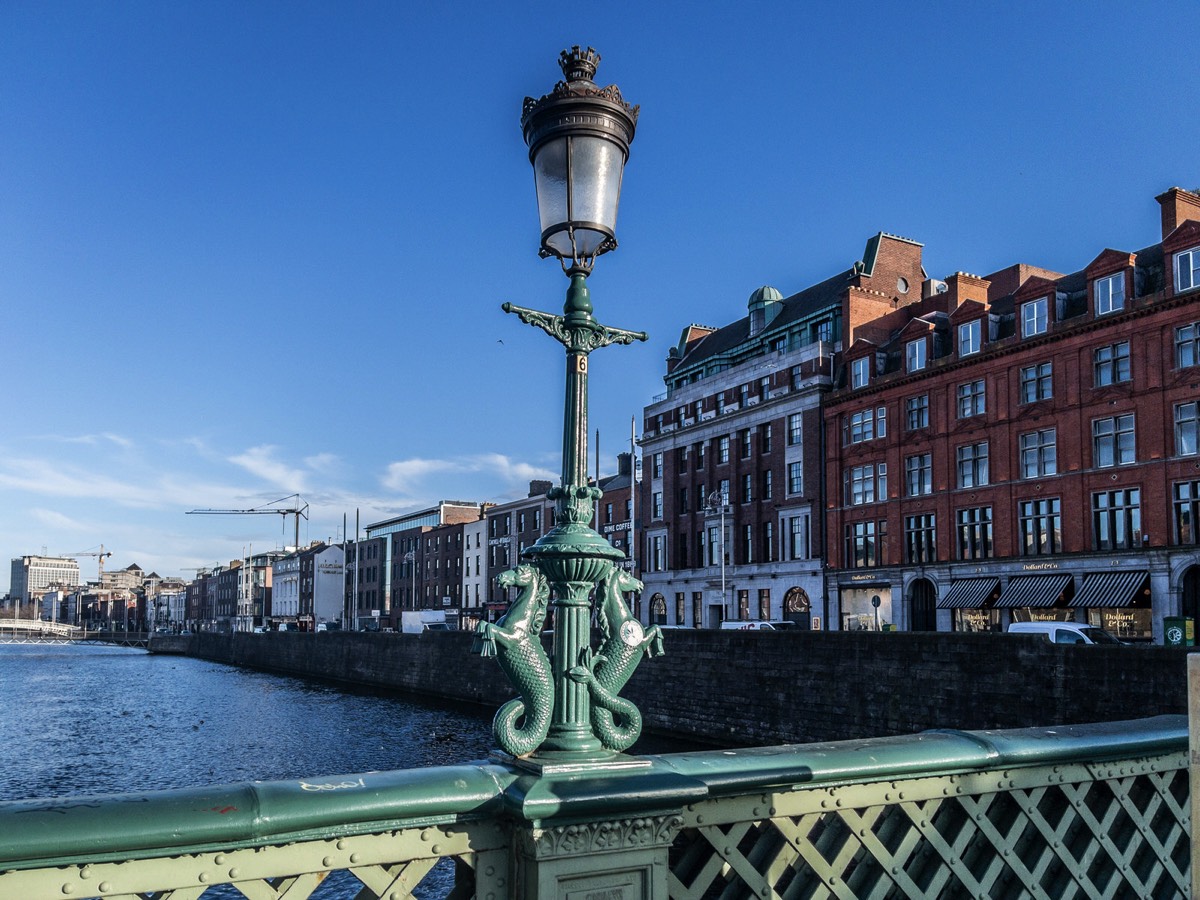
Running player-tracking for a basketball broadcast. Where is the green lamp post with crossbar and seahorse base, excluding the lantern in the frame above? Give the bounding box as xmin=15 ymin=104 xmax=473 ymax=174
xmin=479 ymin=271 xmax=662 ymax=762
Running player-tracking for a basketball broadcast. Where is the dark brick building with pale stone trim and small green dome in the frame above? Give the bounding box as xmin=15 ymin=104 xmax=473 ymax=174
xmin=640 ymin=233 xmax=925 ymax=629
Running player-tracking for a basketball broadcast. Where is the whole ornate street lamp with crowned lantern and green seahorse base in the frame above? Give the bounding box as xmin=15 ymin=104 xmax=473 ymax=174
xmin=478 ymin=47 xmax=661 ymax=764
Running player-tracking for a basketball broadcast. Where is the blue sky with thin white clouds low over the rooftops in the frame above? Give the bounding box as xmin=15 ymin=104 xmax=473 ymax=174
xmin=0 ymin=0 xmax=1200 ymax=590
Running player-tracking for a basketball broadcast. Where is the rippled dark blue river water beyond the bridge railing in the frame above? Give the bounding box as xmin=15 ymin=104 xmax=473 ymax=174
xmin=0 ymin=643 xmax=688 ymax=800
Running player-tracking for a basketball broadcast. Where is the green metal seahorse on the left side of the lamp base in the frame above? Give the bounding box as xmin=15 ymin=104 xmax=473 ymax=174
xmin=474 ymin=565 xmax=554 ymax=756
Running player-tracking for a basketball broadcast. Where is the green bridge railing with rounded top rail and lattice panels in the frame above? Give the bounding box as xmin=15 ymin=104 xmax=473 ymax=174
xmin=0 ymin=716 xmax=1192 ymax=900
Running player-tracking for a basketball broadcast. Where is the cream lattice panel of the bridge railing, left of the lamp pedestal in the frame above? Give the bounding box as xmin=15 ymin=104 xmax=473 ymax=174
xmin=0 ymin=824 xmax=510 ymax=900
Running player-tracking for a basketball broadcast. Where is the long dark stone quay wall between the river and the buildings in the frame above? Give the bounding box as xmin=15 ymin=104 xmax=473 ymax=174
xmin=151 ymin=629 xmax=1188 ymax=746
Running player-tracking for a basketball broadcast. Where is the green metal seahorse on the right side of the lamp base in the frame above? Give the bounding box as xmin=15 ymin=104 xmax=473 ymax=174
xmin=568 ymin=568 xmax=662 ymax=752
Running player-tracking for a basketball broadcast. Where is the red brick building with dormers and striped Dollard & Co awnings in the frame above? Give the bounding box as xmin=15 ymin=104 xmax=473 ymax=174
xmin=822 ymin=188 xmax=1200 ymax=640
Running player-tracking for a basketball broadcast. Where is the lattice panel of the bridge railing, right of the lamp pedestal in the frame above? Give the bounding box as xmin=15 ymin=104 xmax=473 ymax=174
xmin=668 ymin=754 xmax=1190 ymax=900
